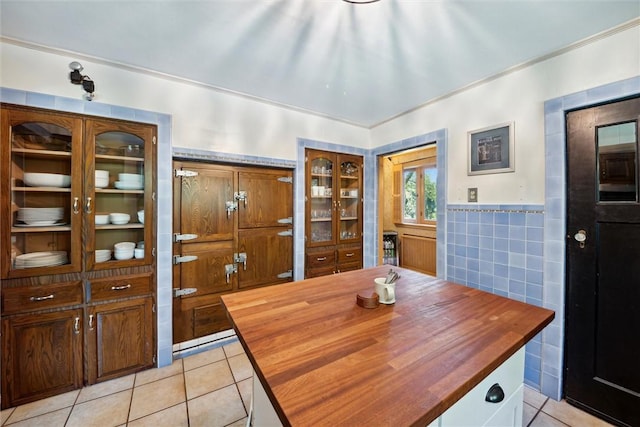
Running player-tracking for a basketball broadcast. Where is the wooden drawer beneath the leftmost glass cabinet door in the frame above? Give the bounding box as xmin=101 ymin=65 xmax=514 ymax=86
xmin=2 ymin=281 xmax=82 ymax=314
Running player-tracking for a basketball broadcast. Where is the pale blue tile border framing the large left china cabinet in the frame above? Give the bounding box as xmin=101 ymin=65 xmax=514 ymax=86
xmin=0 ymin=87 xmax=173 ymax=367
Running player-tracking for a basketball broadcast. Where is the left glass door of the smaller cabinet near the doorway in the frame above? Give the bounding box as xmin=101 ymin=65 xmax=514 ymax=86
xmin=307 ymin=154 xmax=335 ymax=244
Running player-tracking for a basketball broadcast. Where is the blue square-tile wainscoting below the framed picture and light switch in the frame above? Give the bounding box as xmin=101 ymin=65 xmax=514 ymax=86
xmin=447 ymin=205 xmax=544 ymax=390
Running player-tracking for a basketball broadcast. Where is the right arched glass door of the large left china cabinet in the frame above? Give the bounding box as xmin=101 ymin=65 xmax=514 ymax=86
xmin=85 ymin=121 xmax=154 ymax=270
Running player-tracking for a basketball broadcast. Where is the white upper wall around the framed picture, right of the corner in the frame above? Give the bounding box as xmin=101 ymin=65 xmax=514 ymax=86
xmin=371 ymin=26 xmax=640 ymax=204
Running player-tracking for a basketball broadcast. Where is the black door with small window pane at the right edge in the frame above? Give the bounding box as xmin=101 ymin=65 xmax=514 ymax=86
xmin=565 ymin=98 xmax=640 ymax=426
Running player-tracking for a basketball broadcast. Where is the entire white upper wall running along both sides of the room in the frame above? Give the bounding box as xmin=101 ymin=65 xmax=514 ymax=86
xmin=0 ymin=21 xmax=640 ymax=204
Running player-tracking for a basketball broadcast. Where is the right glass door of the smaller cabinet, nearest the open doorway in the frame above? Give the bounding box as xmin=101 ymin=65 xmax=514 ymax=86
xmin=338 ymin=156 xmax=362 ymax=243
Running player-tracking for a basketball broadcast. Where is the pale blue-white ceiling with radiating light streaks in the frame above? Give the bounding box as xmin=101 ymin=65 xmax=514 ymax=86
xmin=0 ymin=0 xmax=640 ymax=127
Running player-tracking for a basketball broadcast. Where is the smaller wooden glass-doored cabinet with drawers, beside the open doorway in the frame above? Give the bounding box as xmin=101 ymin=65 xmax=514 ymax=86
xmin=305 ymin=149 xmax=363 ymax=277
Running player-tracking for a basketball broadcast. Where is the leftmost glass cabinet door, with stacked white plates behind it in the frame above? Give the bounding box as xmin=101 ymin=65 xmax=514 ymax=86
xmin=1 ymin=109 xmax=82 ymax=277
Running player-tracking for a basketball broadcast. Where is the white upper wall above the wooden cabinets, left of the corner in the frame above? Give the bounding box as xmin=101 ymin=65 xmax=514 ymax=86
xmin=0 ymin=40 xmax=369 ymax=160
